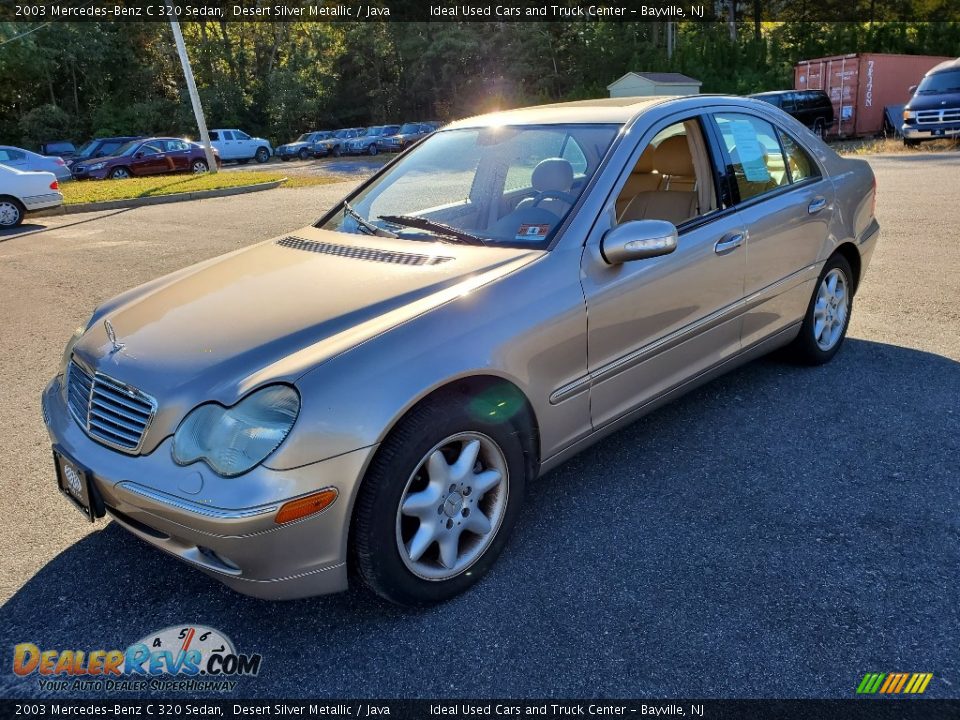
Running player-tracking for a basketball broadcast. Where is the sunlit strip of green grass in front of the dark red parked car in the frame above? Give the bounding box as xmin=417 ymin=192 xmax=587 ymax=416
xmin=60 ymin=172 xmax=336 ymax=205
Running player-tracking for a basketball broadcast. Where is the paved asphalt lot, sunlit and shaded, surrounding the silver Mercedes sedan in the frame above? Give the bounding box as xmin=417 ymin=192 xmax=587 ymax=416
xmin=0 ymin=154 xmax=960 ymax=698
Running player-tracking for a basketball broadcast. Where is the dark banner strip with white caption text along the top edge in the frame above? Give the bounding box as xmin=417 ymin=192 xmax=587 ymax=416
xmin=0 ymin=0 xmax=960 ymax=23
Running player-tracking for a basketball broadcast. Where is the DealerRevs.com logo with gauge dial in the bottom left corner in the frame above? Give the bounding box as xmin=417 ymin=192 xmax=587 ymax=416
xmin=13 ymin=625 xmax=262 ymax=692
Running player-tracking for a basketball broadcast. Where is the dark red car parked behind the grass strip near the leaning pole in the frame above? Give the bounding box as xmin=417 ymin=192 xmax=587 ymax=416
xmin=70 ymin=138 xmax=221 ymax=180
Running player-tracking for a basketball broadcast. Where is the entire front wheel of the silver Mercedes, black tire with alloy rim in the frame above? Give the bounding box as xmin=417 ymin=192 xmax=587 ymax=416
xmin=350 ymin=395 xmax=527 ymax=607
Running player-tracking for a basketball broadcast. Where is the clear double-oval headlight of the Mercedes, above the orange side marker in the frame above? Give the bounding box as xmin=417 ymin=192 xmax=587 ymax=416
xmin=173 ymin=385 xmax=300 ymax=477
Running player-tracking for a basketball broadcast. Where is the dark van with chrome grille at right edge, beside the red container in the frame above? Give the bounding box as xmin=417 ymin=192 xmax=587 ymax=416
xmin=900 ymin=58 xmax=960 ymax=145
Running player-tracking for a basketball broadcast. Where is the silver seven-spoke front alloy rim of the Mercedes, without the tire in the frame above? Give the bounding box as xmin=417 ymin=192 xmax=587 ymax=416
xmin=396 ymin=432 xmax=509 ymax=580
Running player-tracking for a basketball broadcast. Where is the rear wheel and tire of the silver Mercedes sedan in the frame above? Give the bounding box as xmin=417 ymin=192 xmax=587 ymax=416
xmin=786 ymin=254 xmax=853 ymax=365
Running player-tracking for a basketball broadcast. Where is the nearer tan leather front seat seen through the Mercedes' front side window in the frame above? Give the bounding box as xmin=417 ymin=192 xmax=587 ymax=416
xmin=620 ymin=135 xmax=699 ymax=225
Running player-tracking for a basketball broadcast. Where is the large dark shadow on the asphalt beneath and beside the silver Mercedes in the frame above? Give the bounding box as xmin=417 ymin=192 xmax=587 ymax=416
xmin=0 ymin=339 xmax=960 ymax=697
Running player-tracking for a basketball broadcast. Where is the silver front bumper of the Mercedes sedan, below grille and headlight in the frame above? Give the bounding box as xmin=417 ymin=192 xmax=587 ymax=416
xmin=43 ymin=376 xmax=375 ymax=600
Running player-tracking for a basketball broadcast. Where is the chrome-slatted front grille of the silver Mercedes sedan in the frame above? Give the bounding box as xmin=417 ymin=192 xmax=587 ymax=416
xmin=67 ymin=360 xmax=157 ymax=453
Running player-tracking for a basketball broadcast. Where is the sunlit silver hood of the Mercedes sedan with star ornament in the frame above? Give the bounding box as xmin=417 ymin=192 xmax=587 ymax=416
xmin=74 ymin=227 xmax=544 ymax=447
